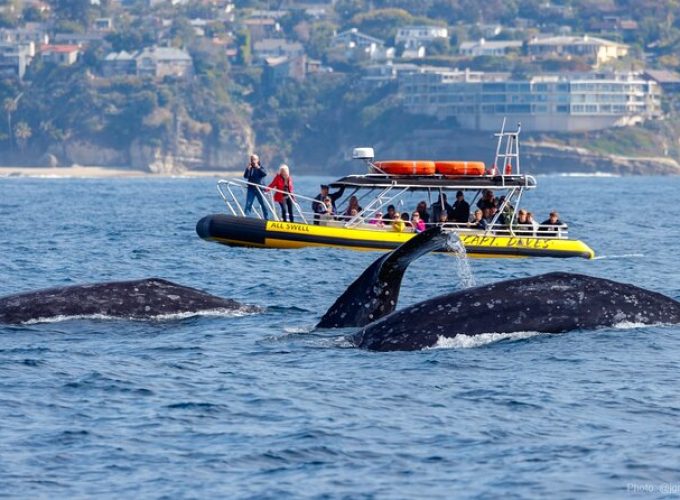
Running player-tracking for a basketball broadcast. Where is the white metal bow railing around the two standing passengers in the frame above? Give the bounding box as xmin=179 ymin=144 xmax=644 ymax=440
xmin=217 ymin=179 xmax=321 ymax=224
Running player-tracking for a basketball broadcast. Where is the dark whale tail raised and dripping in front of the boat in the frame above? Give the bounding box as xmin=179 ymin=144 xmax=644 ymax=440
xmin=316 ymin=227 xmax=454 ymax=328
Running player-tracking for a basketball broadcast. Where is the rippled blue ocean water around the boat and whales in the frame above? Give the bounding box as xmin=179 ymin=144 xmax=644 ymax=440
xmin=0 ymin=177 xmax=680 ymax=498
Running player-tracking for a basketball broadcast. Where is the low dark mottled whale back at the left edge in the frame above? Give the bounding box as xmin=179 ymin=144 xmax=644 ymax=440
xmin=0 ymin=278 xmax=259 ymax=324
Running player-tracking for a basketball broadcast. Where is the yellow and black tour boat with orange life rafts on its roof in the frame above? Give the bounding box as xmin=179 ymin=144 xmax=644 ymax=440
xmin=196 ymin=122 xmax=595 ymax=259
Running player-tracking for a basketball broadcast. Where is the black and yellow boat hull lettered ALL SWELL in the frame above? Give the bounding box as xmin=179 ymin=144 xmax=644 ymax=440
xmin=196 ymin=214 xmax=595 ymax=259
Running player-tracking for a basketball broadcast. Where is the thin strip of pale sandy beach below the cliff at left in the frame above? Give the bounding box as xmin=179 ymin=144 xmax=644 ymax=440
xmin=0 ymin=165 xmax=241 ymax=178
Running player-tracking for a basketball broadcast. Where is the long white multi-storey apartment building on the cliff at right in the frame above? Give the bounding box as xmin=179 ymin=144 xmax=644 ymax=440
xmin=398 ymin=68 xmax=661 ymax=132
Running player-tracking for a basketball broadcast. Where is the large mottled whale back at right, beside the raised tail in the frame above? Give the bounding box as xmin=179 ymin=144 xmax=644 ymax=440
xmin=351 ymin=272 xmax=680 ymax=351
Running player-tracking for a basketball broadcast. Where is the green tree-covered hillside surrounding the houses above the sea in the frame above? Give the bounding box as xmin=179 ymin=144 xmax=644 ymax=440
xmin=0 ymin=0 xmax=680 ymax=173
